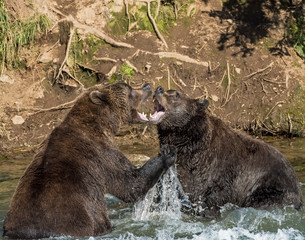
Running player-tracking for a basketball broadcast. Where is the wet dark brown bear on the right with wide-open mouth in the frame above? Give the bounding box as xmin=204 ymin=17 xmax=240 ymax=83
xmin=150 ymin=87 xmax=302 ymax=217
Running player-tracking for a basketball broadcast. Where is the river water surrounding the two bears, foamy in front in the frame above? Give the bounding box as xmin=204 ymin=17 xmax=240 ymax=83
xmin=0 ymin=139 xmax=305 ymax=240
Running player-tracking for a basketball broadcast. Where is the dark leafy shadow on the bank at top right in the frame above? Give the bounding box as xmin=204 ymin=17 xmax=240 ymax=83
xmin=202 ymin=0 xmax=305 ymax=57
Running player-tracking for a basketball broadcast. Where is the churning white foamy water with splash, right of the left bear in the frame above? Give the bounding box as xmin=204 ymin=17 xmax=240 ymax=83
xmin=97 ymin=176 xmax=305 ymax=240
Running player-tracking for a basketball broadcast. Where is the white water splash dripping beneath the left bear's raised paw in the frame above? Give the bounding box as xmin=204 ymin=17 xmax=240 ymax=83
xmin=133 ymin=166 xmax=182 ymax=220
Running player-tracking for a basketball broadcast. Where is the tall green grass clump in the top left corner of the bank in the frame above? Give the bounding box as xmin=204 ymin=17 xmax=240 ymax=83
xmin=0 ymin=1 xmax=50 ymax=72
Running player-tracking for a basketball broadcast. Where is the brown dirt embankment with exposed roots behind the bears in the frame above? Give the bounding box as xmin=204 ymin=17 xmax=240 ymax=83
xmin=0 ymin=0 xmax=305 ymax=149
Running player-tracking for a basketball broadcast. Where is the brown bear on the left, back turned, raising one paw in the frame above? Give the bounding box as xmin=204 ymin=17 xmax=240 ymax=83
xmin=4 ymin=83 xmax=175 ymax=238
